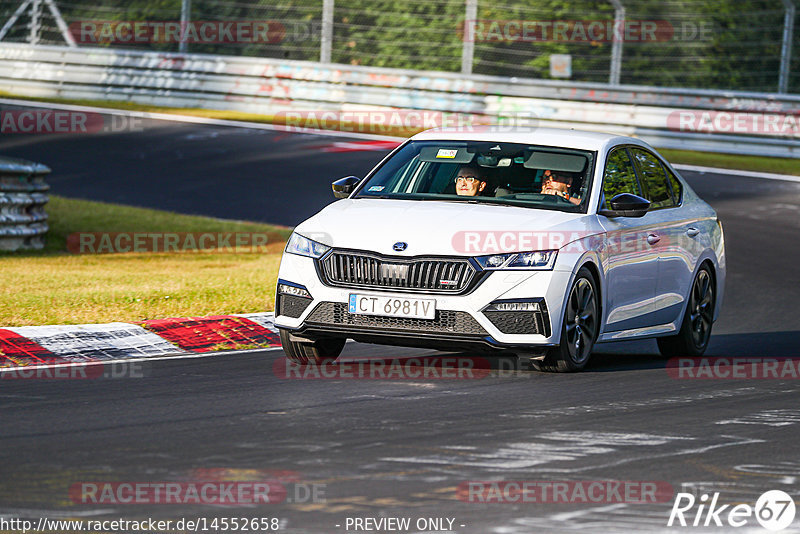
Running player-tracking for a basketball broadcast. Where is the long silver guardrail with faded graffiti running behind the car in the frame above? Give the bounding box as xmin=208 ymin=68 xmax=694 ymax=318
xmin=0 ymin=43 xmax=800 ymax=157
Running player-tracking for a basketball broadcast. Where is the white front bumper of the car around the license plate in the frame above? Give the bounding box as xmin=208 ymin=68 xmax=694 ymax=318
xmin=275 ymin=254 xmax=572 ymax=350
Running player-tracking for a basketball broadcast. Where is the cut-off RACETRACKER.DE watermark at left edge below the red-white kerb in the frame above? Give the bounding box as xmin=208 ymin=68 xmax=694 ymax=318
xmin=0 ymin=362 xmax=150 ymax=380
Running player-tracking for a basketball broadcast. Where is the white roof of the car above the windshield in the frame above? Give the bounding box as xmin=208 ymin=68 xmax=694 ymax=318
xmin=411 ymin=126 xmax=650 ymax=151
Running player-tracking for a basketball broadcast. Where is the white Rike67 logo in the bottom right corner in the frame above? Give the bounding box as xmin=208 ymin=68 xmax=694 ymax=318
xmin=667 ymin=490 xmax=795 ymax=532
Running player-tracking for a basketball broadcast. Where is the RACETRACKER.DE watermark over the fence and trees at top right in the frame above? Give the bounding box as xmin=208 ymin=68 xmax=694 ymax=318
xmin=459 ymin=19 xmax=714 ymax=43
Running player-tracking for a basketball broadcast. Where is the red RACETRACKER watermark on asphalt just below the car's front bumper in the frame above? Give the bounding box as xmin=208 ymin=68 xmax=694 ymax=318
xmin=272 ymin=357 xmax=496 ymax=380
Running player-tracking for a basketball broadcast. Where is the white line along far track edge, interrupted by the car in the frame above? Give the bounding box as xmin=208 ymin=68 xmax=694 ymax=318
xmin=0 ymin=98 xmax=800 ymax=183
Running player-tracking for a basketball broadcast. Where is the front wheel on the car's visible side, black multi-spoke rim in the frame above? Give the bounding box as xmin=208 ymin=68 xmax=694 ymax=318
xmin=531 ymin=267 xmax=600 ymax=373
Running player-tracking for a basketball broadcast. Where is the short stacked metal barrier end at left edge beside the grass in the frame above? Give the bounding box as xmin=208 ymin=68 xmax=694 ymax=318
xmin=0 ymin=158 xmax=50 ymax=251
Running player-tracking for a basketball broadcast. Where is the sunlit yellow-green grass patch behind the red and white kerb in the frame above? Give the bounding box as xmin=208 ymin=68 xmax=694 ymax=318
xmin=0 ymin=196 xmax=290 ymax=327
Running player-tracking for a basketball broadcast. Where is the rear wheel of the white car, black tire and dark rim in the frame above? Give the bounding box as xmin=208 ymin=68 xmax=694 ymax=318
xmin=658 ymin=265 xmax=716 ymax=358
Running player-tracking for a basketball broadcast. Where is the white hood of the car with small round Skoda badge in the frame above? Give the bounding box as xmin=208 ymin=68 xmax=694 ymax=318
xmin=295 ymin=199 xmax=602 ymax=256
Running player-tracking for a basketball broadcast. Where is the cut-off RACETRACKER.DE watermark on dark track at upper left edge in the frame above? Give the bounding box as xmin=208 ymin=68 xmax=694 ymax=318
xmin=0 ymin=109 xmax=144 ymax=134
